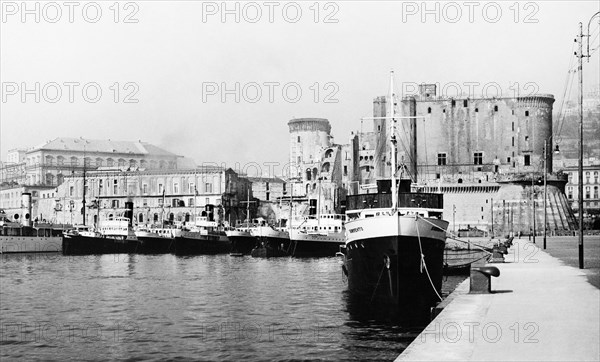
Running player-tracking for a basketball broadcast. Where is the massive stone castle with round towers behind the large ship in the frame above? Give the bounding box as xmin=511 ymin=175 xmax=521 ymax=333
xmin=288 ymin=85 xmax=576 ymax=235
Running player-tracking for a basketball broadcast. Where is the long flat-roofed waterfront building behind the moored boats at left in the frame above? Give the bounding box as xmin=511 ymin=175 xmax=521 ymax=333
xmin=27 ymin=166 xmax=251 ymax=224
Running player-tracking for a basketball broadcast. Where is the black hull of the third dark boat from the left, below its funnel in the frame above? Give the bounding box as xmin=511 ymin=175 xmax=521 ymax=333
xmin=174 ymin=232 xmax=231 ymax=255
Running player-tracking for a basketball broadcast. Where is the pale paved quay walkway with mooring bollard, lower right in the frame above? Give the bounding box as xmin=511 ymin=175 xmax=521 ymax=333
xmin=396 ymin=239 xmax=600 ymax=361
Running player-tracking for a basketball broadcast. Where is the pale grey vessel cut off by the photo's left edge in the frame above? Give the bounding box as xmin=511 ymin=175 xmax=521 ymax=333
xmin=0 ymin=192 xmax=62 ymax=254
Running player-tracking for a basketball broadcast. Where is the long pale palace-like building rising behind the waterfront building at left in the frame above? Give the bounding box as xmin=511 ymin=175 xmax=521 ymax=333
xmin=0 ymin=137 xmax=183 ymax=186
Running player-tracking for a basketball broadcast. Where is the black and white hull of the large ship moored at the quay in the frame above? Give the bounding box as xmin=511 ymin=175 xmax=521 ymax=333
xmin=343 ymin=217 xmax=448 ymax=321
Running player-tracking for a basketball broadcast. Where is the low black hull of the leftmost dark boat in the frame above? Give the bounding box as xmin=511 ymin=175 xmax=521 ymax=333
xmin=62 ymin=235 xmax=138 ymax=255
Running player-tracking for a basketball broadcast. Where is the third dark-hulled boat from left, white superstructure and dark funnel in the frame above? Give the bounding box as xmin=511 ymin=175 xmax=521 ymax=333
xmin=175 ymin=205 xmax=231 ymax=255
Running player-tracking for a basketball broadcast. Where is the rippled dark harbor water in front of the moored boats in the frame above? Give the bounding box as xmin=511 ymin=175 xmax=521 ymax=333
xmin=0 ymin=254 xmax=464 ymax=361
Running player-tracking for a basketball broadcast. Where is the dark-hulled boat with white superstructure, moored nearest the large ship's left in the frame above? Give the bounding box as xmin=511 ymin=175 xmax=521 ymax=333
xmin=290 ymin=214 xmax=346 ymax=257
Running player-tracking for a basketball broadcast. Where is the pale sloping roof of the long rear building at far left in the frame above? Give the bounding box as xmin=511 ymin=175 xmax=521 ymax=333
xmin=30 ymin=137 xmax=178 ymax=157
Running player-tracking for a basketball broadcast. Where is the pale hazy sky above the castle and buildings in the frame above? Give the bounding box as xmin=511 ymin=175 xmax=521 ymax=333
xmin=0 ymin=1 xmax=600 ymax=175
